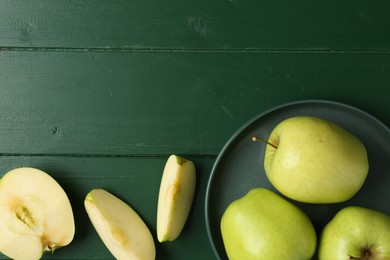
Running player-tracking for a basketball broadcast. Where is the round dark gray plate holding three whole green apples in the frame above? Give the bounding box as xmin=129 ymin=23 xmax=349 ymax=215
xmin=205 ymin=100 xmax=390 ymax=259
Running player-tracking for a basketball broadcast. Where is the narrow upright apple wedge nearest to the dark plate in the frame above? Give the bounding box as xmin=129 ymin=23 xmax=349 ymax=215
xmin=157 ymin=155 xmax=196 ymax=242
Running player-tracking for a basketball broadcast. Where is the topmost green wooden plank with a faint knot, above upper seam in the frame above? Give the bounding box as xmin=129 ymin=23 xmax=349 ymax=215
xmin=0 ymin=0 xmax=390 ymax=51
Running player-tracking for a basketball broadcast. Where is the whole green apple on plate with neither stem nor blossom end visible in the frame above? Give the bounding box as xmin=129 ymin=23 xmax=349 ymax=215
xmin=221 ymin=188 xmax=317 ymax=260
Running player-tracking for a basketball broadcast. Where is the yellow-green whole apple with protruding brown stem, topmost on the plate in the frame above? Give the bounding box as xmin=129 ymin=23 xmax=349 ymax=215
xmin=264 ymin=116 xmax=369 ymax=203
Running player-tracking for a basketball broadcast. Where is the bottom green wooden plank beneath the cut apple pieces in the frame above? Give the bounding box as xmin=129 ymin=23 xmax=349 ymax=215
xmin=0 ymin=156 xmax=214 ymax=260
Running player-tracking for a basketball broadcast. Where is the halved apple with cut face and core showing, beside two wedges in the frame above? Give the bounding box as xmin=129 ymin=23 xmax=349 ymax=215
xmin=0 ymin=168 xmax=75 ymax=259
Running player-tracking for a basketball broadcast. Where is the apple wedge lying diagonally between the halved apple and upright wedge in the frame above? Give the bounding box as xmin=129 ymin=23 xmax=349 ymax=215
xmin=84 ymin=189 xmax=156 ymax=260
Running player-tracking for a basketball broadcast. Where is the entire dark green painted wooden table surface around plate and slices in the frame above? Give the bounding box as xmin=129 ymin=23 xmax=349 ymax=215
xmin=0 ymin=0 xmax=390 ymax=260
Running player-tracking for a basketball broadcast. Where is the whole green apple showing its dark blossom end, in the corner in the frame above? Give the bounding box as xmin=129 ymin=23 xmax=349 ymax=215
xmin=318 ymin=206 xmax=390 ymax=260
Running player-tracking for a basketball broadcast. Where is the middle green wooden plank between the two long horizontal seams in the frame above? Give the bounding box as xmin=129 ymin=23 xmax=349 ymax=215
xmin=0 ymin=51 xmax=390 ymax=155
